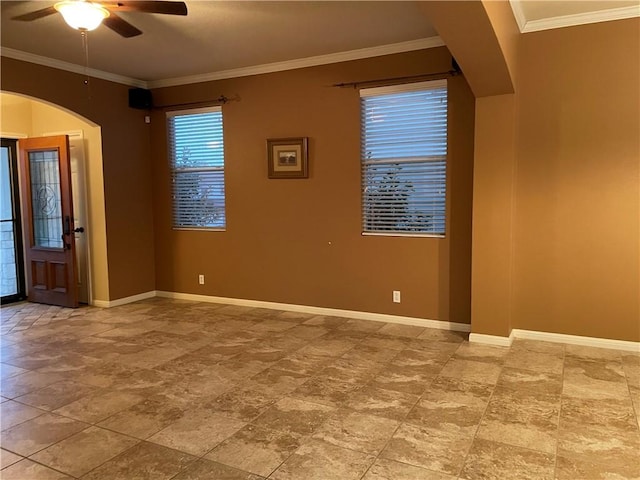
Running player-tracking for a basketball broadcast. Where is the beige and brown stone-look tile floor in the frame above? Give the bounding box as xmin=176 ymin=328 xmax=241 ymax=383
xmin=0 ymin=299 xmax=640 ymax=480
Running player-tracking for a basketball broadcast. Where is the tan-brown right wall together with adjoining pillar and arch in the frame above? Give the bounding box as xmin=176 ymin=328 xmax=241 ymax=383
xmin=423 ymin=1 xmax=640 ymax=341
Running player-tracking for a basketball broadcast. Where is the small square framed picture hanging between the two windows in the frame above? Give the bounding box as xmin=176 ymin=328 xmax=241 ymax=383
xmin=267 ymin=137 xmax=309 ymax=178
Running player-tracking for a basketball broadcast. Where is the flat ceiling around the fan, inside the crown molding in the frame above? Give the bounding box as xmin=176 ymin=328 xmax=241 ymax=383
xmin=1 ymin=1 xmax=436 ymax=81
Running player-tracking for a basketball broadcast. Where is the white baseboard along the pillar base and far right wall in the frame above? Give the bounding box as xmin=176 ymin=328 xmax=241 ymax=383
xmin=469 ymin=328 xmax=640 ymax=353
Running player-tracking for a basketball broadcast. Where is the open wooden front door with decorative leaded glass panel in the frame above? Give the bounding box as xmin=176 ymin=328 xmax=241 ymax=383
xmin=18 ymin=135 xmax=78 ymax=308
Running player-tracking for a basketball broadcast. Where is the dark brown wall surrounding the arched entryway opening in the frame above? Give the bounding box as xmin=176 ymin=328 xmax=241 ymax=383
xmin=1 ymin=57 xmax=155 ymax=300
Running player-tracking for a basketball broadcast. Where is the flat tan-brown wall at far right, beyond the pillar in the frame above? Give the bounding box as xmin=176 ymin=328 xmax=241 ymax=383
xmin=513 ymin=19 xmax=640 ymax=341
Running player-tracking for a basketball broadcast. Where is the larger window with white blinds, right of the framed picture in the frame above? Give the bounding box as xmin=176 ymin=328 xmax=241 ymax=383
xmin=360 ymin=80 xmax=447 ymax=236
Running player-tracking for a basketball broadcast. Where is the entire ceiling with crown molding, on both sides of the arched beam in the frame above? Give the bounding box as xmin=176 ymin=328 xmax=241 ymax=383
xmin=0 ymin=0 xmax=640 ymax=86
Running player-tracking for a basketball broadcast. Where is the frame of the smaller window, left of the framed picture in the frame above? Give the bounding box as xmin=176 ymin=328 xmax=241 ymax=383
xmin=166 ymin=105 xmax=227 ymax=232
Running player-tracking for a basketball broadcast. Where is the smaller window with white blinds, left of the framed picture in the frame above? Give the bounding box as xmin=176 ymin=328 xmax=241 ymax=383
xmin=167 ymin=107 xmax=226 ymax=230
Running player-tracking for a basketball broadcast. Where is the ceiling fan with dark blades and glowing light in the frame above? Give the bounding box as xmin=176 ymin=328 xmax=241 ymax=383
xmin=13 ymin=0 xmax=187 ymax=38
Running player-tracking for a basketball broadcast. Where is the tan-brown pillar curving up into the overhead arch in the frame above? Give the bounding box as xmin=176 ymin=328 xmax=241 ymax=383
xmin=421 ymin=1 xmax=520 ymax=337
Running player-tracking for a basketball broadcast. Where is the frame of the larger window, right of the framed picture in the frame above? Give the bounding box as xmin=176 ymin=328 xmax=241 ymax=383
xmin=359 ymin=79 xmax=449 ymax=239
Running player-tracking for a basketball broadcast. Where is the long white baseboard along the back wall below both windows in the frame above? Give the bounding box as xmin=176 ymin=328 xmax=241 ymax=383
xmin=156 ymin=291 xmax=471 ymax=332
